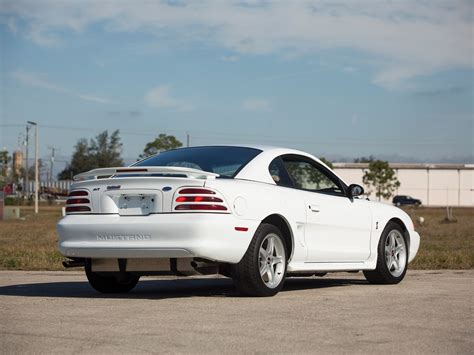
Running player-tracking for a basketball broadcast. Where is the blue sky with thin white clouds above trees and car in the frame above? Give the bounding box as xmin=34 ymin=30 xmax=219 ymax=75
xmin=0 ymin=0 xmax=474 ymax=175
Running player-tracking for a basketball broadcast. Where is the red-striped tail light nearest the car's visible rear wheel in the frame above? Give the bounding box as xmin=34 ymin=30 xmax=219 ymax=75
xmin=173 ymin=187 xmax=228 ymax=213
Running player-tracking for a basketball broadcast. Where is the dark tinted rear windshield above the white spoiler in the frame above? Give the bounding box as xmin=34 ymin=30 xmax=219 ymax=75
xmin=133 ymin=147 xmax=262 ymax=178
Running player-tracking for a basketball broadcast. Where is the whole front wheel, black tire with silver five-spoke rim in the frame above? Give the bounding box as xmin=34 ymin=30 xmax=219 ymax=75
xmin=364 ymin=222 xmax=408 ymax=284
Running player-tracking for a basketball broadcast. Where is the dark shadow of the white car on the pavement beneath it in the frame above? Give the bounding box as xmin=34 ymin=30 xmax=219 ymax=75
xmin=0 ymin=277 xmax=367 ymax=299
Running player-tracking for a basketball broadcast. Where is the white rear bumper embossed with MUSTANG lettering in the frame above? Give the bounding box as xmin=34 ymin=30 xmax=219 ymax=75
xmin=57 ymin=213 xmax=259 ymax=263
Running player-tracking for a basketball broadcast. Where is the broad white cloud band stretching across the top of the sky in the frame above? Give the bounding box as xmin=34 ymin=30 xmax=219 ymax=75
xmin=0 ymin=0 xmax=474 ymax=87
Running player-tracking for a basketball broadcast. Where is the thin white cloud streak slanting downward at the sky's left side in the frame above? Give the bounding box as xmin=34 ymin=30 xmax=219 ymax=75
xmin=12 ymin=70 xmax=113 ymax=104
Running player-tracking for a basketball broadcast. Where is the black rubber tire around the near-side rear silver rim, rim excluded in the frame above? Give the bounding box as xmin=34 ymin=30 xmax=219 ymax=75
xmin=232 ymin=223 xmax=288 ymax=297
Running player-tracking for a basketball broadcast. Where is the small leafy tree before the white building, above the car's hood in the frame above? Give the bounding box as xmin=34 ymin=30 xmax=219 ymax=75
xmin=362 ymin=160 xmax=400 ymax=201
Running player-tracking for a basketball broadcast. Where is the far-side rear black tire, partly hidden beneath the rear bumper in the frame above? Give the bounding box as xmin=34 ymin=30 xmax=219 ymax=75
xmin=85 ymin=265 xmax=140 ymax=293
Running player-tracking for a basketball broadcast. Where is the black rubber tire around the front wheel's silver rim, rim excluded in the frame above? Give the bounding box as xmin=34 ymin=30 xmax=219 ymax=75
xmin=363 ymin=222 xmax=408 ymax=285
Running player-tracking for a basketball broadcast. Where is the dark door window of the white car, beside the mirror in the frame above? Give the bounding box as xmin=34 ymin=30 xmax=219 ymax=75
xmin=283 ymin=157 xmax=343 ymax=195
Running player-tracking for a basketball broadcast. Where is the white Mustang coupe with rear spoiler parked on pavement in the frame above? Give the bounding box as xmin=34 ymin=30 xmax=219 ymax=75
xmin=57 ymin=146 xmax=420 ymax=296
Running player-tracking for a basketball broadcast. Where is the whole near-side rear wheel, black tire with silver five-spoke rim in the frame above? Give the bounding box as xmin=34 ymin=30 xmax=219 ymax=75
xmin=233 ymin=224 xmax=287 ymax=297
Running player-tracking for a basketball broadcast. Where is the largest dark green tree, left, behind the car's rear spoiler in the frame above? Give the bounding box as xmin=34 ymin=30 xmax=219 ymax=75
xmin=58 ymin=130 xmax=123 ymax=180
